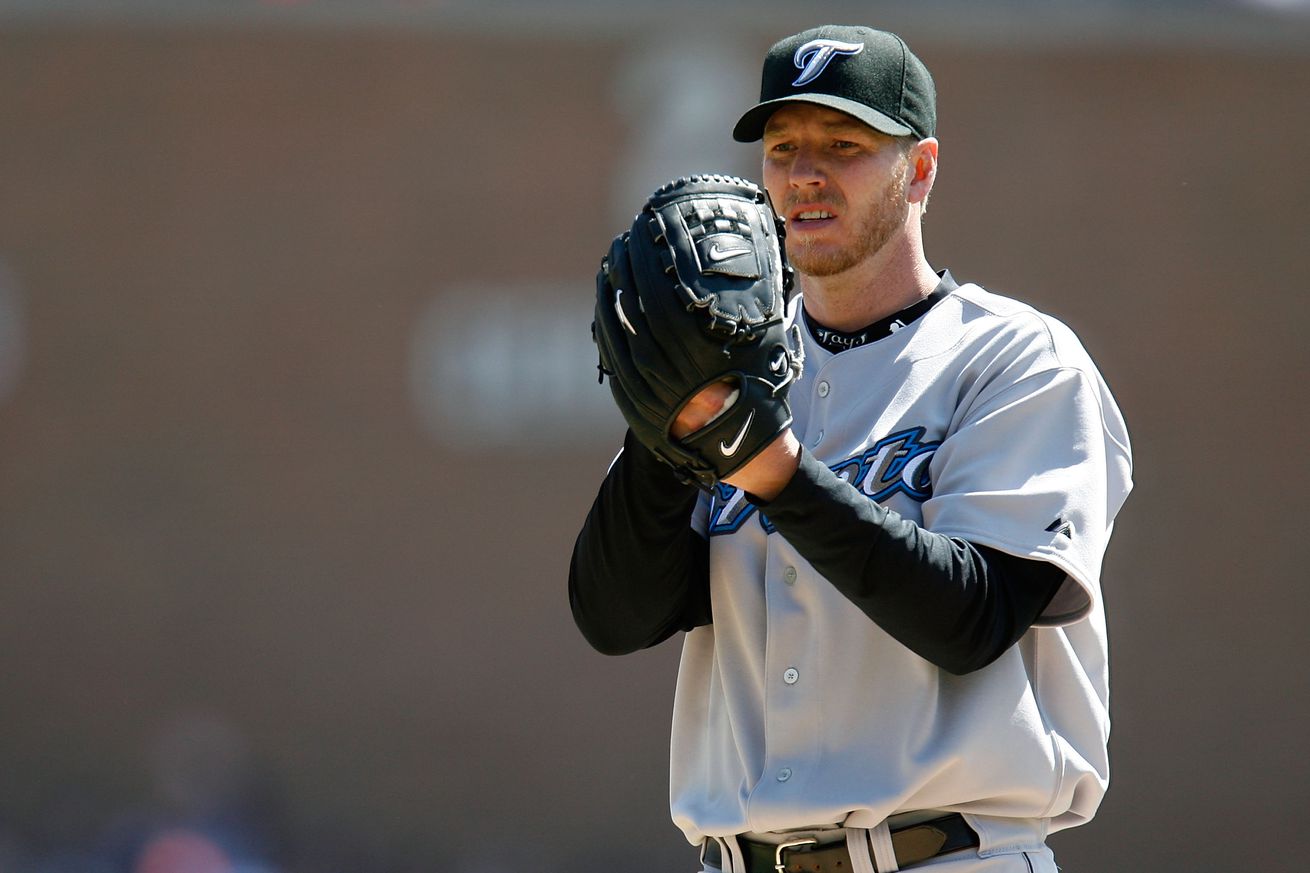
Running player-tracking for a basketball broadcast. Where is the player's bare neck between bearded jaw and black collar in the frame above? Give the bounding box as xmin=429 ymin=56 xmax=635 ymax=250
xmin=800 ymin=234 xmax=938 ymax=330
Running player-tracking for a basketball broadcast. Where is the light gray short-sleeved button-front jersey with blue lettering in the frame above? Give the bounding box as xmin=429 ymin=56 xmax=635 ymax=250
xmin=671 ymin=284 xmax=1132 ymax=843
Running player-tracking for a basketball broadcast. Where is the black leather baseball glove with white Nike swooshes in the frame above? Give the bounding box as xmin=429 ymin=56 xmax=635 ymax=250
xmin=592 ymin=176 xmax=803 ymax=489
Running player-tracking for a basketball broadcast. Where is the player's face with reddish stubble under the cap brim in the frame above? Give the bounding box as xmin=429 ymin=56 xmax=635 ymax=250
xmin=764 ymin=104 xmax=909 ymax=275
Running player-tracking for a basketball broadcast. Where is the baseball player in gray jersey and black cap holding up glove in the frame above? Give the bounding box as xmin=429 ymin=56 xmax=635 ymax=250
xmin=570 ymin=26 xmax=1132 ymax=873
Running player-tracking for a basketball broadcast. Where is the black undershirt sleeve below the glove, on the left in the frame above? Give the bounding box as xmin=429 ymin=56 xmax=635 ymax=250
xmin=569 ymin=433 xmax=710 ymax=654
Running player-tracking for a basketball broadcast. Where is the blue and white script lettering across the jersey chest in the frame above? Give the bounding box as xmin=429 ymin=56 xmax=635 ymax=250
xmin=709 ymin=427 xmax=942 ymax=536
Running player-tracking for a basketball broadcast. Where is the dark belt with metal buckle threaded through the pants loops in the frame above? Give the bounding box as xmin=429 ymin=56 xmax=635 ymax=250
xmin=705 ymin=813 xmax=979 ymax=873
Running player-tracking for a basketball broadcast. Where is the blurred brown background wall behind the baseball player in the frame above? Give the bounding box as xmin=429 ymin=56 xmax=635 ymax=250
xmin=0 ymin=0 xmax=1310 ymax=873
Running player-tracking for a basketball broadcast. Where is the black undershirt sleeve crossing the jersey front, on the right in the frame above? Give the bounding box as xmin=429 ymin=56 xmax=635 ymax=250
xmin=757 ymin=450 xmax=1065 ymax=675
